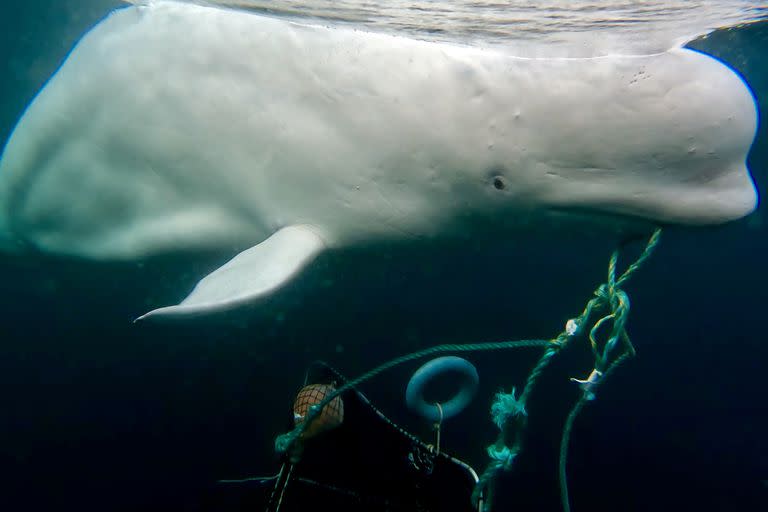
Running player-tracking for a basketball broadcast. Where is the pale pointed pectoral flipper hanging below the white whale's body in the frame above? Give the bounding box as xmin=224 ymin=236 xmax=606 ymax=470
xmin=136 ymin=225 xmax=325 ymax=321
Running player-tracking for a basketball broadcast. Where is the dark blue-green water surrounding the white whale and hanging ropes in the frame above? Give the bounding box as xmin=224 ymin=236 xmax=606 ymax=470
xmin=0 ymin=0 xmax=768 ymax=512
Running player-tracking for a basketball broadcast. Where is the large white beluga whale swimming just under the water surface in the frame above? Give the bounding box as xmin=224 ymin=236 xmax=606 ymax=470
xmin=0 ymin=0 xmax=757 ymax=318
